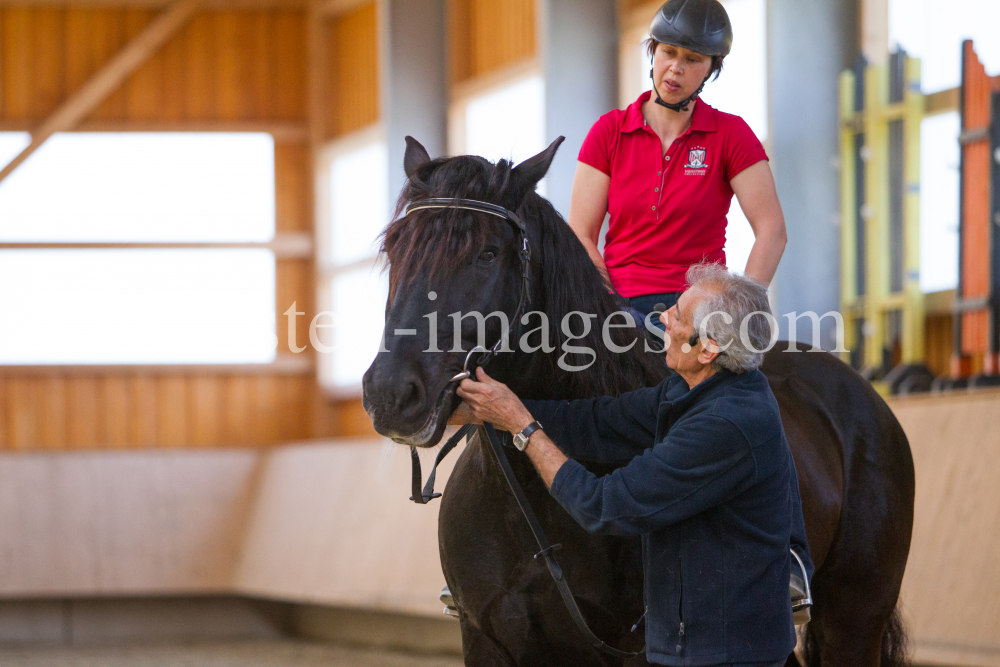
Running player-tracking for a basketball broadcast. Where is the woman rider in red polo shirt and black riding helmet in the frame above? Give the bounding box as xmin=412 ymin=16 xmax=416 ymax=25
xmin=569 ymin=0 xmax=786 ymax=322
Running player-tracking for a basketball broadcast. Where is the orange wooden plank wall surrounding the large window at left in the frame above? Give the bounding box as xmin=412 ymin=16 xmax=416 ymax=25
xmin=0 ymin=6 xmax=360 ymax=450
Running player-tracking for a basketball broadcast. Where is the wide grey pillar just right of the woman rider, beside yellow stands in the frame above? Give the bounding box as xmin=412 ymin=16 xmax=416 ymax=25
xmin=768 ymin=0 xmax=859 ymax=349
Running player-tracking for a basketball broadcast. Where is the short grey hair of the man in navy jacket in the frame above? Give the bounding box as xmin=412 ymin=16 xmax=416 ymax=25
xmin=686 ymin=264 xmax=777 ymax=373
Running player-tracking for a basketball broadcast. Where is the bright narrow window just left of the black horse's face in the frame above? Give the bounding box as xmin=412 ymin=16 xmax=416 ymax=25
xmin=315 ymin=128 xmax=390 ymax=395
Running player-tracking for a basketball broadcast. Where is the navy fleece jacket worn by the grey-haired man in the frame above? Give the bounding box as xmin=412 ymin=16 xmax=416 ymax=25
xmin=524 ymin=370 xmax=812 ymax=665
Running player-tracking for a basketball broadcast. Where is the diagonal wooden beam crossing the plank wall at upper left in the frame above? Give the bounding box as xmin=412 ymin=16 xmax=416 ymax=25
xmin=0 ymin=0 xmax=202 ymax=183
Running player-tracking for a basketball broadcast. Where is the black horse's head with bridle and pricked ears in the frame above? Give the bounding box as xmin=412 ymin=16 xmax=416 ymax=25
xmin=363 ymin=137 xmax=562 ymax=447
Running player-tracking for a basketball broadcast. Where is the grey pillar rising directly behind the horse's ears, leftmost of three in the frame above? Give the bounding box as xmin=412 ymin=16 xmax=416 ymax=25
xmin=379 ymin=0 xmax=448 ymax=210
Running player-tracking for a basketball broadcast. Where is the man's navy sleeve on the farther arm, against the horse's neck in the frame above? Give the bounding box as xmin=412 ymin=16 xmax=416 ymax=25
xmin=524 ymin=384 xmax=665 ymax=463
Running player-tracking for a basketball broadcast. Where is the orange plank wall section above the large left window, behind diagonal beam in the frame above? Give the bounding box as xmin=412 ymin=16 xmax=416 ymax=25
xmin=0 ymin=7 xmax=306 ymax=121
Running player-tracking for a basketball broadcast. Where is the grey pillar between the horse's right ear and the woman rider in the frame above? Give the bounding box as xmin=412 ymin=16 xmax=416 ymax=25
xmin=538 ymin=0 xmax=618 ymax=217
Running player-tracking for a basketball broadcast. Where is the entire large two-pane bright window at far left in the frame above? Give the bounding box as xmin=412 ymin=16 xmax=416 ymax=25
xmin=0 ymin=133 xmax=276 ymax=364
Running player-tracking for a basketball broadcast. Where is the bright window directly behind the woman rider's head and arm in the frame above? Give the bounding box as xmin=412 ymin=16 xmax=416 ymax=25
xmin=637 ymin=0 xmax=768 ymax=272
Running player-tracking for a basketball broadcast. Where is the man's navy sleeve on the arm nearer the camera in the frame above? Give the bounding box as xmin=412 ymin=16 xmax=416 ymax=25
xmin=549 ymin=415 xmax=757 ymax=535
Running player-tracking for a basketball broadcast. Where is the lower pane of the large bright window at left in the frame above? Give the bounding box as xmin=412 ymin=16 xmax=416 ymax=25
xmin=0 ymin=249 xmax=276 ymax=365
